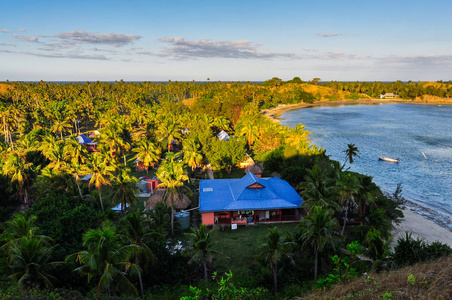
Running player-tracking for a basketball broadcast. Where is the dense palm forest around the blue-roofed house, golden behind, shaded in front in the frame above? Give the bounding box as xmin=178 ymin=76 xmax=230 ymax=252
xmin=0 ymin=78 xmax=452 ymax=299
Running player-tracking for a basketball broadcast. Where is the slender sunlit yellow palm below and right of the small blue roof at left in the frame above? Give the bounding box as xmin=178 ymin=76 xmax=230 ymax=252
xmin=88 ymin=153 xmax=115 ymax=211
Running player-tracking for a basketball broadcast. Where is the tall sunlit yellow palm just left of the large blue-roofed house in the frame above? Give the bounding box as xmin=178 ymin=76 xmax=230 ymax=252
xmin=156 ymin=152 xmax=191 ymax=237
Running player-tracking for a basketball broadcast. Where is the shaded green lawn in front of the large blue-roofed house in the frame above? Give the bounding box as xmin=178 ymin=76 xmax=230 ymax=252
xmin=209 ymin=222 xmax=298 ymax=273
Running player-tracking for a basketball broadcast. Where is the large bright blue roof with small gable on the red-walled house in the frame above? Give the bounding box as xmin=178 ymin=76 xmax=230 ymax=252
xmin=199 ymin=173 xmax=303 ymax=212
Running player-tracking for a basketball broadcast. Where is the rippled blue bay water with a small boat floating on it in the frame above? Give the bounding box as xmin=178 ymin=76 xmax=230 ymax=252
xmin=281 ymin=104 xmax=452 ymax=227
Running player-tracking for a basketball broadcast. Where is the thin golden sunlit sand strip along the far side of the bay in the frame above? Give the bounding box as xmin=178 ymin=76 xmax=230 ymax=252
xmin=261 ymin=99 xmax=452 ymax=122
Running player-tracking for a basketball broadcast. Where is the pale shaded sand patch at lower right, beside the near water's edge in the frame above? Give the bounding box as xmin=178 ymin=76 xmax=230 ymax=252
xmin=393 ymin=209 xmax=452 ymax=247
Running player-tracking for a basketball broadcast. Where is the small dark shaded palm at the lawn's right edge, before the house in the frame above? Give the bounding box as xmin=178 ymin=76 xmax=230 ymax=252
xmin=259 ymin=226 xmax=293 ymax=292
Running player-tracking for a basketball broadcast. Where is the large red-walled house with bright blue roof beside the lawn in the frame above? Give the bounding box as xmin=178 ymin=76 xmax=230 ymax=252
xmin=199 ymin=172 xmax=303 ymax=225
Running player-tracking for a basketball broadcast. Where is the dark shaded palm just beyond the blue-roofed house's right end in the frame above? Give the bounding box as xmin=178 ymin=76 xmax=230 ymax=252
xmin=299 ymin=206 xmax=338 ymax=282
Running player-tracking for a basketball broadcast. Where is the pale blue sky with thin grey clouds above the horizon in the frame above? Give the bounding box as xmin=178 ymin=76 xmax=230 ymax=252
xmin=0 ymin=0 xmax=452 ymax=82
